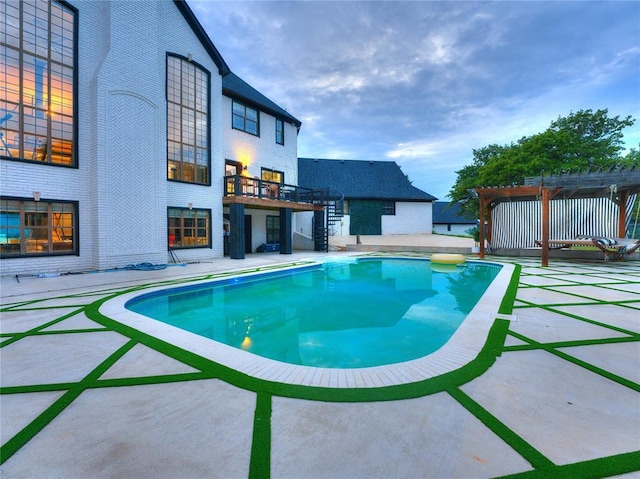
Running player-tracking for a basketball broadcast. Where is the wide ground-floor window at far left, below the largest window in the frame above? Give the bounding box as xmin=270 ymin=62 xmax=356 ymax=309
xmin=0 ymin=198 xmax=78 ymax=258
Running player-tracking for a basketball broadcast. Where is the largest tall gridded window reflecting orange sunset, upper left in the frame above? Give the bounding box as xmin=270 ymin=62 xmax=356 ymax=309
xmin=0 ymin=0 xmax=77 ymax=166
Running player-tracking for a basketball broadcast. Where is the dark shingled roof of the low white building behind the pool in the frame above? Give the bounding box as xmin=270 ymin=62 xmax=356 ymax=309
xmin=298 ymin=158 xmax=437 ymax=201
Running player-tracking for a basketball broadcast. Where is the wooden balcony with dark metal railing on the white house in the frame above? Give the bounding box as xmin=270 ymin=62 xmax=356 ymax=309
xmin=222 ymin=175 xmax=326 ymax=211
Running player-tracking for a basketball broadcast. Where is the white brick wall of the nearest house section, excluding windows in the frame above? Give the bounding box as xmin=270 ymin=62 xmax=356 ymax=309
xmin=0 ymin=0 xmax=224 ymax=274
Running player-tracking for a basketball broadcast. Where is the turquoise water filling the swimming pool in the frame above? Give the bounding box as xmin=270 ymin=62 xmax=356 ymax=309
xmin=126 ymin=258 xmax=501 ymax=368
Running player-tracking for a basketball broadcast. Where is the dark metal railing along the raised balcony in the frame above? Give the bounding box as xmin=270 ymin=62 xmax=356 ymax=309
xmin=224 ymin=175 xmax=326 ymax=205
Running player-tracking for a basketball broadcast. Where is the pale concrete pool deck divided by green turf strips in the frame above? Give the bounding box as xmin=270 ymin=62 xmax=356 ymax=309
xmin=0 ymin=244 xmax=640 ymax=478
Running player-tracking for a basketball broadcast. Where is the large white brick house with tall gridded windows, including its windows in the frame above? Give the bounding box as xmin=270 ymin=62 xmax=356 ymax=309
xmin=0 ymin=0 xmax=310 ymax=275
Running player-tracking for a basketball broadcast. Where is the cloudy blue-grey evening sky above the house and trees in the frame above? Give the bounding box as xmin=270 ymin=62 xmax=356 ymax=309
xmin=188 ymin=0 xmax=640 ymax=200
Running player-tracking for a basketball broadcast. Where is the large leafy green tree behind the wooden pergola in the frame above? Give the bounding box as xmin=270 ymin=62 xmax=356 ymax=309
xmin=447 ymin=109 xmax=640 ymax=218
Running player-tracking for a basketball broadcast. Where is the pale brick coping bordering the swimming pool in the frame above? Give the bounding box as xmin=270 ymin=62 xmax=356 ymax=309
xmin=99 ymin=255 xmax=515 ymax=389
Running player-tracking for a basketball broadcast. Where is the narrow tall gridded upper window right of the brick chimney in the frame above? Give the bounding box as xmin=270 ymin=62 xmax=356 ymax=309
xmin=167 ymin=55 xmax=211 ymax=185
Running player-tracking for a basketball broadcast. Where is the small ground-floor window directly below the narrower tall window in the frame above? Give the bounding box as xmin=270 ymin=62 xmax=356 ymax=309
xmin=168 ymin=208 xmax=211 ymax=248
